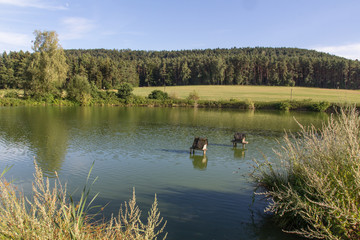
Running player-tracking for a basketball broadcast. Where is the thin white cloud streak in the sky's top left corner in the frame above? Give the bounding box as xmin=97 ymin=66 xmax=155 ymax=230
xmin=0 ymin=0 xmax=67 ymax=10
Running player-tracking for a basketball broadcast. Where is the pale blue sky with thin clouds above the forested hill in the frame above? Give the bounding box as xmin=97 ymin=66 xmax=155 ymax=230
xmin=0 ymin=0 xmax=360 ymax=59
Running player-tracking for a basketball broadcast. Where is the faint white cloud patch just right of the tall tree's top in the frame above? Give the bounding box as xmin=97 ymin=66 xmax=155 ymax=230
xmin=60 ymin=17 xmax=96 ymax=40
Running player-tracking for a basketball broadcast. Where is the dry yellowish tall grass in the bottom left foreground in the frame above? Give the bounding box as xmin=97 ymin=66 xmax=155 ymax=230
xmin=0 ymin=163 xmax=167 ymax=239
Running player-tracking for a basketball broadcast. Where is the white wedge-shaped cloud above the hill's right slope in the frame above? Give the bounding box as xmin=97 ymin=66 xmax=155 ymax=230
xmin=314 ymin=43 xmax=360 ymax=60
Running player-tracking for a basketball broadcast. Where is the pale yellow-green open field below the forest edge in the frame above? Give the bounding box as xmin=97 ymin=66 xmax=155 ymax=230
xmin=134 ymin=85 xmax=360 ymax=104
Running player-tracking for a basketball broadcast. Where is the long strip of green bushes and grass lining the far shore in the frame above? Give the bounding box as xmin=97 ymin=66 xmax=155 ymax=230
xmin=0 ymin=90 xmax=350 ymax=112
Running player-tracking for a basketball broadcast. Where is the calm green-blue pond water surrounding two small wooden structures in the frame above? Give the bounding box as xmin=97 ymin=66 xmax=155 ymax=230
xmin=0 ymin=107 xmax=328 ymax=239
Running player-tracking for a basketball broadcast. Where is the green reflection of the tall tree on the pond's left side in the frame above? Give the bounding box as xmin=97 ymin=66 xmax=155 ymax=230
xmin=0 ymin=107 xmax=68 ymax=177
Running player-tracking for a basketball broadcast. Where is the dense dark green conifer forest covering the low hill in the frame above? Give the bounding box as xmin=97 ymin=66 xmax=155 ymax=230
xmin=0 ymin=47 xmax=360 ymax=89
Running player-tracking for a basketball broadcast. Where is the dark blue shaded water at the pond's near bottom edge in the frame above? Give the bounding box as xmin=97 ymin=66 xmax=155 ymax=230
xmin=158 ymin=188 xmax=304 ymax=240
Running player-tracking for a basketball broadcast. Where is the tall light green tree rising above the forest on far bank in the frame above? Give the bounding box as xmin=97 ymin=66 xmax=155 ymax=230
xmin=25 ymin=30 xmax=68 ymax=97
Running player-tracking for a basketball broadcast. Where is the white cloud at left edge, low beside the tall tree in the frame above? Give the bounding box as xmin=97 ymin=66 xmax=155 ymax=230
xmin=0 ymin=32 xmax=31 ymax=50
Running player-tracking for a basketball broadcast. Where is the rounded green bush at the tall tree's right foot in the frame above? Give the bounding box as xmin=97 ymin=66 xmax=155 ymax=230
xmin=67 ymin=75 xmax=92 ymax=105
